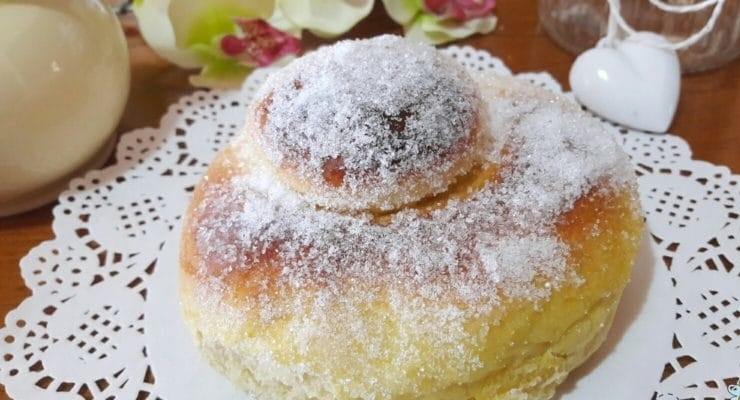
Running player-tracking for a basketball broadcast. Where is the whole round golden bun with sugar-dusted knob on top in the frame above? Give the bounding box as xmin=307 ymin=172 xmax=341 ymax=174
xmin=181 ymin=36 xmax=642 ymax=400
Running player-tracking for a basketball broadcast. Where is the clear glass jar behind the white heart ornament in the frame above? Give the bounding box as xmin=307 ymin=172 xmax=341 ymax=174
xmin=539 ymin=0 xmax=740 ymax=72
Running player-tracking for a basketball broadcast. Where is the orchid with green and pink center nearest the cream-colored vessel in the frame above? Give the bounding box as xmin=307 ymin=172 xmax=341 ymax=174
xmin=134 ymin=0 xmax=300 ymax=87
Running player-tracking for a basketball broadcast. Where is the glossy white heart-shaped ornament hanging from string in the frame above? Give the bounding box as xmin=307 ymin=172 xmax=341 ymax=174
xmin=570 ymin=32 xmax=681 ymax=132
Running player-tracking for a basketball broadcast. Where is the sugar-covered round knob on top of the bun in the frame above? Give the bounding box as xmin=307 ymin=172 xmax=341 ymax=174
xmin=246 ymin=35 xmax=480 ymax=209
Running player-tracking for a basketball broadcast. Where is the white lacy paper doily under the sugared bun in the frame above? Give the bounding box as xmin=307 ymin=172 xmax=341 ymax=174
xmin=0 ymin=46 xmax=740 ymax=400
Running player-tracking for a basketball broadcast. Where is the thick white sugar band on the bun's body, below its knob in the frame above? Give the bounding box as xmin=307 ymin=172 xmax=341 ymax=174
xmin=189 ymin=92 xmax=631 ymax=314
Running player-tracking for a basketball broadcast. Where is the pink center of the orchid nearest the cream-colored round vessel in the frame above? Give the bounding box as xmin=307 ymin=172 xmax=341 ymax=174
xmin=220 ymin=19 xmax=301 ymax=67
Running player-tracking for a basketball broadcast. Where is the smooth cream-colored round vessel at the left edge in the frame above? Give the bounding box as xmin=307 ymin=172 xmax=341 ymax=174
xmin=0 ymin=0 xmax=130 ymax=216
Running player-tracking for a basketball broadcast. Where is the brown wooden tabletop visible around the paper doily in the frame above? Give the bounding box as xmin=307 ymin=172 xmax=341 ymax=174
xmin=0 ymin=0 xmax=740 ymax=400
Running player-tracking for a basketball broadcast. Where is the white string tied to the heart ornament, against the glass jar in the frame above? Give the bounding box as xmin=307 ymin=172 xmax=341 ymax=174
xmin=598 ymin=0 xmax=726 ymax=50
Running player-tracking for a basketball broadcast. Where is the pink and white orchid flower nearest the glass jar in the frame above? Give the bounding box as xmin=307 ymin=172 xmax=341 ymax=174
xmin=383 ymin=0 xmax=496 ymax=44
